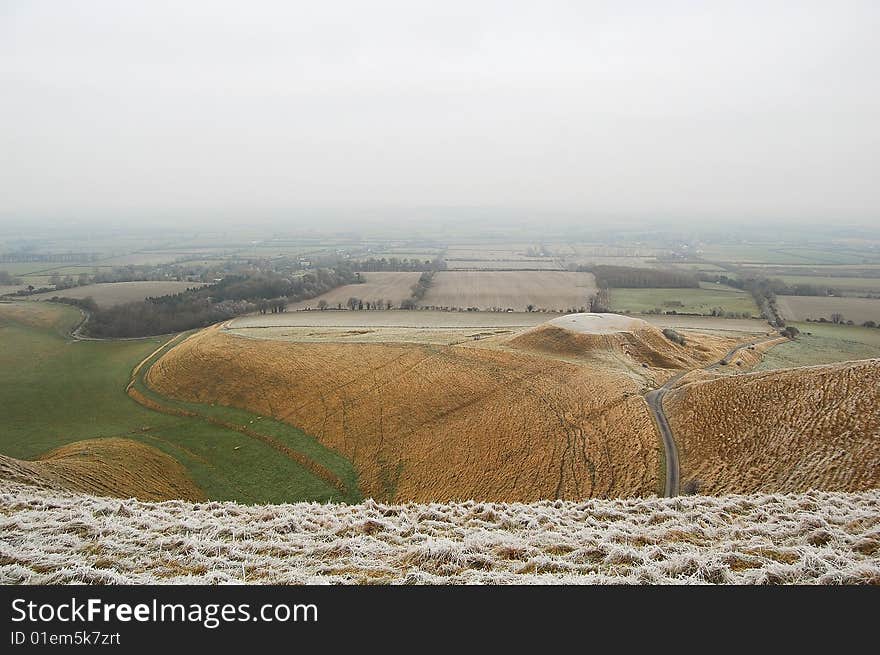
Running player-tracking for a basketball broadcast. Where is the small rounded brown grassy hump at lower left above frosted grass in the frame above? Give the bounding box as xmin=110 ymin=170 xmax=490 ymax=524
xmin=0 ymin=439 xmax=205 ymax=500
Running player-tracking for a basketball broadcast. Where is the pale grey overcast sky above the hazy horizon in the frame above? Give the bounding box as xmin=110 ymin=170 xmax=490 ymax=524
xmin=0 ymin=0 xmax=880 ymax=222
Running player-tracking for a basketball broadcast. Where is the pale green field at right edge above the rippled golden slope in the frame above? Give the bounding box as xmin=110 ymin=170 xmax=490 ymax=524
xmin=755 ymin=323 xmax=880 ymax=371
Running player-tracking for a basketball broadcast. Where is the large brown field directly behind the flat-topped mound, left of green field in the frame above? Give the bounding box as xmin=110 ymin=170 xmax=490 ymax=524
xmin=420 ymin=271 xmax=596 ymax=312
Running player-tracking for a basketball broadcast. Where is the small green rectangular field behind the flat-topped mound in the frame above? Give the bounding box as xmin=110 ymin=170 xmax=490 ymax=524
xmin=610 ymin=283 xmax=760 ymax=316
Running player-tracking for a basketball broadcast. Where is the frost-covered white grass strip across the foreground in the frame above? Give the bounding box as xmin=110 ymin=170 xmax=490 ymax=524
xmin=0 ymin=482 xmax=880 ymax=584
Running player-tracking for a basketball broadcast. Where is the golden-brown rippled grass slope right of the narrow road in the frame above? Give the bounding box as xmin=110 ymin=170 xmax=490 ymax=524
xmin=665 ymin=359 xmax=880 ymax=494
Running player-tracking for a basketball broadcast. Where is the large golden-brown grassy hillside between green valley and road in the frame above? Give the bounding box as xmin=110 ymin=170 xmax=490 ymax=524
xmin=147 ymin=329 xmax=659 ymax=502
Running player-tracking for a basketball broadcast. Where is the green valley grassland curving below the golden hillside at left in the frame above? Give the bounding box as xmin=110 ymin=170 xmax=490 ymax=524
xmin=0 ymin=303 xmax=359 ymax=503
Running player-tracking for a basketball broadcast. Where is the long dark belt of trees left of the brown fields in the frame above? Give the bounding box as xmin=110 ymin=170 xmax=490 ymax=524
xmin=59 ymin=268 xmax=357 ymax=337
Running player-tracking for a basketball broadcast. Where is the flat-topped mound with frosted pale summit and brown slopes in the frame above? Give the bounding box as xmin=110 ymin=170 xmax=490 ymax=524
xmin=508 ymin=313 xmax=735 ymax=369
